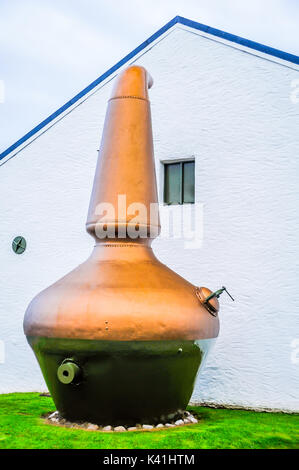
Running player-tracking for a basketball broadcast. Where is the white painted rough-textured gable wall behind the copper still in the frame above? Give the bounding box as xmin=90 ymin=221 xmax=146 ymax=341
xmin=0 ymin=27 xmax=299 ymax=410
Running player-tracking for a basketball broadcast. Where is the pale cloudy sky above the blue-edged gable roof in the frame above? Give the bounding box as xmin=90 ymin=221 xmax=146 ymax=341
xmin=0 ymin=0 xmax=299 ymax=152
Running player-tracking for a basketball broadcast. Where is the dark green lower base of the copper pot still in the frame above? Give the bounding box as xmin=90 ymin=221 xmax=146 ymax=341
xmin=27 ymin=337 xmax=203 ymax=425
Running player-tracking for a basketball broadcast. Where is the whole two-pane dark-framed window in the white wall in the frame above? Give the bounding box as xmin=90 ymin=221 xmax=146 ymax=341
xmin=164 ymin=161 xmax=195 ymax=204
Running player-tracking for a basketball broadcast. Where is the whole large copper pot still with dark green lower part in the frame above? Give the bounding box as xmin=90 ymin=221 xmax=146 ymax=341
xmin=24 ymin=65 xmax=233 ymax=425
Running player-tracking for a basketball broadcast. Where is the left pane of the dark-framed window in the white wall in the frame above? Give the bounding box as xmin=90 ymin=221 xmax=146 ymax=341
xmin=164 ymin=163 xmax=182 ymax=204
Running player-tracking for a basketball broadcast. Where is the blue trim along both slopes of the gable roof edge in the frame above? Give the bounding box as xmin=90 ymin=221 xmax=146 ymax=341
xmin=0 ymin=16 xmax=299 ymax=160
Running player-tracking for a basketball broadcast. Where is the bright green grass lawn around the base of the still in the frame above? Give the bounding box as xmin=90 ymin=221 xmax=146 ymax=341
xmin=0 ymin=393 xmax=299 ymax=449
